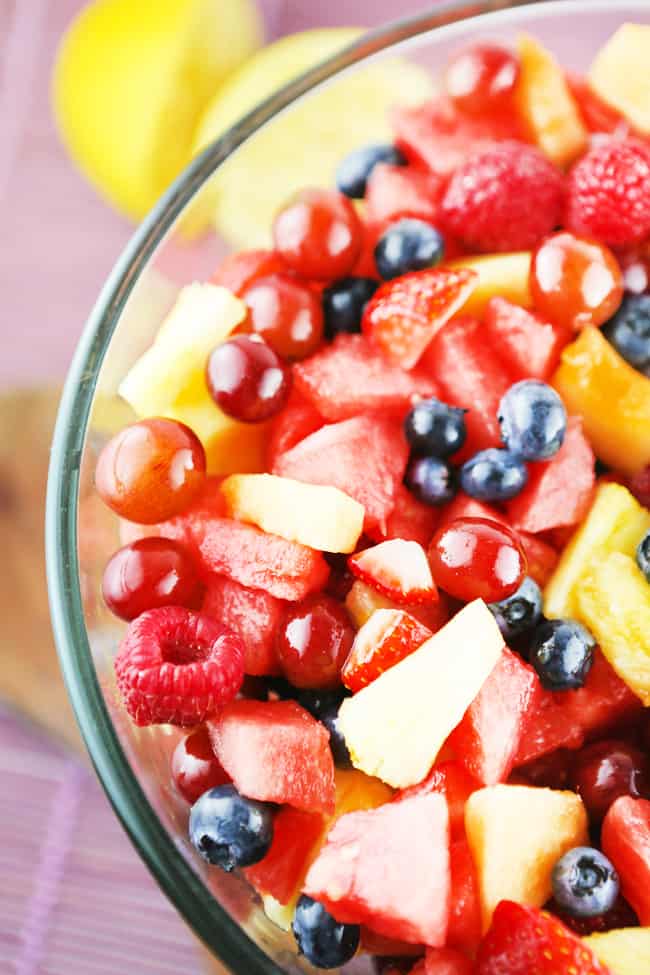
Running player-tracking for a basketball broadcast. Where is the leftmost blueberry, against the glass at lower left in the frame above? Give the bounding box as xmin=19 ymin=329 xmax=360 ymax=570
xmin=189 ymin=785 xmax=274 ymax=873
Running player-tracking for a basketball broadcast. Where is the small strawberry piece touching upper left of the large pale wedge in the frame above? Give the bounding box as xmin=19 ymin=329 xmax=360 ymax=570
xmin=341 ymin=609 xmax=433 ymax=693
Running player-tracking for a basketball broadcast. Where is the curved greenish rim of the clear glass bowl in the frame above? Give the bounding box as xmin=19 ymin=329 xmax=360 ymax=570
xmin=45 ymin=0 xmax=632 ymax=975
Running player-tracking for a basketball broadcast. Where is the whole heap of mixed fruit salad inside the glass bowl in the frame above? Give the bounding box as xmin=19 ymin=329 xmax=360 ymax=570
xmin=96 ymin=26 xmax=650 ymax=975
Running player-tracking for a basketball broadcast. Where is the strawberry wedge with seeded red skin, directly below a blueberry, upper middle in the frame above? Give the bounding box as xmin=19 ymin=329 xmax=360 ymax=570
xmin=361 ymin=267 xmax=478 ymax=369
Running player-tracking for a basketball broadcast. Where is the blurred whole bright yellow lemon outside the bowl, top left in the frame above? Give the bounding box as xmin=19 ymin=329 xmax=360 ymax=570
xmin=53 ymin=0 xmax=261 ymax=219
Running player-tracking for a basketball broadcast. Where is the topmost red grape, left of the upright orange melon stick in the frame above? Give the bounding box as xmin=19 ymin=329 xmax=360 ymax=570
xmin=445 ymin=44 xmax=519 ymax=115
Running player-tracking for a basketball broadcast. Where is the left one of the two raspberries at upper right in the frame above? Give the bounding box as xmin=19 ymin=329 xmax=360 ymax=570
xmin=441 ymin=141 xmax=564 ymax=252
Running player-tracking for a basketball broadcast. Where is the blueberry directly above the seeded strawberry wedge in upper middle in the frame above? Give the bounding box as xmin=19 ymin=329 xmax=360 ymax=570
xmin=375 ymin=217 xmax=445 ymax=281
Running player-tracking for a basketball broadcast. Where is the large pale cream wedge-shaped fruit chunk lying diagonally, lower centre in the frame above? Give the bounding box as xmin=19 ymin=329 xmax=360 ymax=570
xmin=339 ymin=599 xmax=504 ymax=788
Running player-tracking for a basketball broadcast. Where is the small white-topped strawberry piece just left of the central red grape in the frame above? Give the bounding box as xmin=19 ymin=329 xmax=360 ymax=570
xmin=348 ymin=538 xmax=438 ymax=606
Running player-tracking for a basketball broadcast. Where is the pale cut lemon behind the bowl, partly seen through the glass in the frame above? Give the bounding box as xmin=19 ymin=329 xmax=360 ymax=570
xmin=185 ymin=28 xmax=432 ymax=247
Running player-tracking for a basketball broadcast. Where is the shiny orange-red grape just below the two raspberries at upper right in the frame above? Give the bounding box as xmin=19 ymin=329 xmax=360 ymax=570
xmin=530 ymin=231 xmax=623 ymax=331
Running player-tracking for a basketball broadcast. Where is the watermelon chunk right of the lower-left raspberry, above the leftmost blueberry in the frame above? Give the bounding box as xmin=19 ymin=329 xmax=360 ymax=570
xmin=208 ymin=699 xmax=335 ymax=813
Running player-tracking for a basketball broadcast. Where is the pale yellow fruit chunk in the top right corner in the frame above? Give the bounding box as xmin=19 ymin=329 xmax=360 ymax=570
xmin=589 ymin=24 xmax=650 ymax=135
